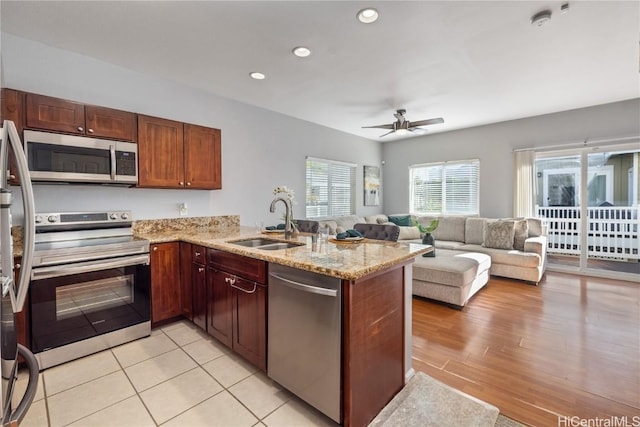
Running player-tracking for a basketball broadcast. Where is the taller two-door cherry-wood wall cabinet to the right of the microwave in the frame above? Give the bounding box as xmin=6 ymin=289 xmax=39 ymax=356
xmin=138 ymin=115 xmax=222 ymax=190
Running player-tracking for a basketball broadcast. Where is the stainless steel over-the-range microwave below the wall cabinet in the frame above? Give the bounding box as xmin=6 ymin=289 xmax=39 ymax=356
xmin=24 ymin=130 xmax=138 ymax=185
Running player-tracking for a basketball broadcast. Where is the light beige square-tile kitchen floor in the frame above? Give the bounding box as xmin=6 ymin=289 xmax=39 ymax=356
xmin=16 ymin=321 xmax=336 ymax=427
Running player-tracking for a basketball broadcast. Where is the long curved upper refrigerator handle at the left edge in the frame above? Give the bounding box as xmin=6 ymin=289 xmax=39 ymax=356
xmin=2 ymin=120 xmax=36 ymax=313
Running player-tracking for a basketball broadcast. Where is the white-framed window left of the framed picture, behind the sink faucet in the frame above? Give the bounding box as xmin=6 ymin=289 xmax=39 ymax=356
xmin=306 ymin=157 xmax=356 ymax=218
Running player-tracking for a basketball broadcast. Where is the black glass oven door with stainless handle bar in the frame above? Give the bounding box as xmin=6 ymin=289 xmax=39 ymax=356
xmin=30 ymin=254 xmax=151 ymax=353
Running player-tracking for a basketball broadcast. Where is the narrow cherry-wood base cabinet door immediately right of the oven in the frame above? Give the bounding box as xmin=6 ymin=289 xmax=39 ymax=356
xmin=151 ymin=242 xmax=181 ymax=322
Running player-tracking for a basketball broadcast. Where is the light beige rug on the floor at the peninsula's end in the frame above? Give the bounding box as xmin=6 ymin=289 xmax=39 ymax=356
xmin=369 ymin=372 xmax=500 ymax=427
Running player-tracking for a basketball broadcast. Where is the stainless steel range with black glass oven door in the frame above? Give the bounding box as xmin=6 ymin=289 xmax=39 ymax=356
xmin=30 ymin=211 xmax=151 ymax=369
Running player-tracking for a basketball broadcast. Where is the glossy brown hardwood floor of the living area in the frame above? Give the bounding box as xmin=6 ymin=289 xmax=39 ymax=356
xmin=413 ymin=272 xmax=640 ymax=426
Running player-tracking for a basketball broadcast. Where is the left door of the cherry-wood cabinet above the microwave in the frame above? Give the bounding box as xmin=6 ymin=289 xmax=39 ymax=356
xmin=26 ymin=93 xmax=84 ymax=135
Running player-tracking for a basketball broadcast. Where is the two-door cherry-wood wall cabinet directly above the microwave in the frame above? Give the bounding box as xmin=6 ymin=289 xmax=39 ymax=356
xmin=25 ymin=93 xmax=136 ymax=141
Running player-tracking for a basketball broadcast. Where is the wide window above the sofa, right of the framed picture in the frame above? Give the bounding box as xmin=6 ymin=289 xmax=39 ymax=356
xmin=409 ymin=160 xmax=480 ymax=215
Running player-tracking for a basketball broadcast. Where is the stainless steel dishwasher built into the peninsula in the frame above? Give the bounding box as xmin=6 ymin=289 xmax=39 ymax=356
xmin=267 ymin=264 xmax=342 ymax=423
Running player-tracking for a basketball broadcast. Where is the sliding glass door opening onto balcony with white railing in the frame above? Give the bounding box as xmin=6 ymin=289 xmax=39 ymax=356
xmin=535 ymin=144 xmax=640 ymax=278
